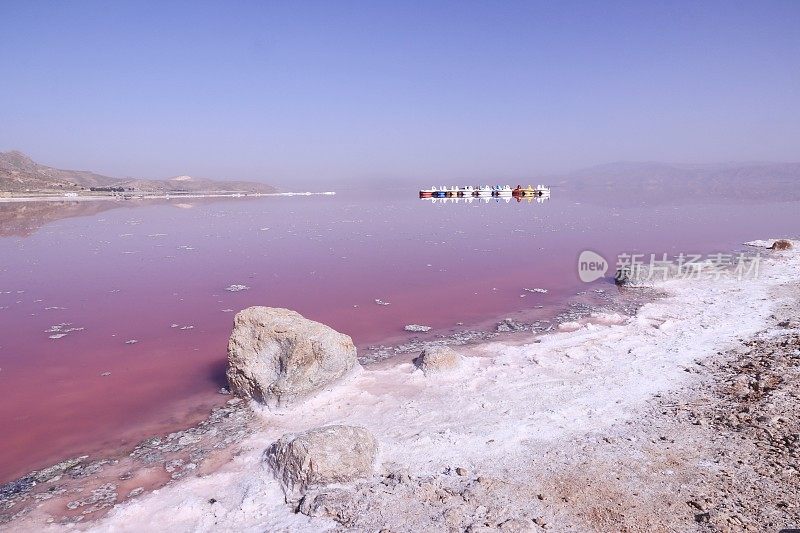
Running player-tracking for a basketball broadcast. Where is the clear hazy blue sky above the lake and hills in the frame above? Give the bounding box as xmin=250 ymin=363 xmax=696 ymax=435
xmin=0 ymin=0 xmax=800 ymax=184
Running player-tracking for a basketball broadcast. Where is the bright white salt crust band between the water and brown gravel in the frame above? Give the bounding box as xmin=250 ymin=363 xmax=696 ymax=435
xmin=32 ymin=242 xmax=800 ymax=531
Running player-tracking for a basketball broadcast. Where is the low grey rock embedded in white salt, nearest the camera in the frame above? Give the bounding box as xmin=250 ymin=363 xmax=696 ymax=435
xmin=265 ymin=426 xmax=377 ymax=502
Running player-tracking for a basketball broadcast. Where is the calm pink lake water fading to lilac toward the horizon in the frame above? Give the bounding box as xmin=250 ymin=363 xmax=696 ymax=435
xmin=0 ymin=190 xmax=800 ymax=482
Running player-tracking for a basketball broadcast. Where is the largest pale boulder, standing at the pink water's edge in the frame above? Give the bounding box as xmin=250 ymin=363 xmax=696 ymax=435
xmin=226 ymin=307 xmax=358 ymax=407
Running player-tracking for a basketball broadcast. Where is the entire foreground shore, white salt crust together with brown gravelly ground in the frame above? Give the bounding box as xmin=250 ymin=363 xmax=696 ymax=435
xmin=7 ymin=243 xmax=800 ymax=531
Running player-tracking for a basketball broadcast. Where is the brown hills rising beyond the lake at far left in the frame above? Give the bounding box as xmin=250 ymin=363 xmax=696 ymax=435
xmin=0 ymin=151 xmax=277 ymax=193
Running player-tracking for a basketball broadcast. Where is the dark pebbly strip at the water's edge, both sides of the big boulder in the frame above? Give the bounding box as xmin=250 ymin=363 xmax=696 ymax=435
xmin=0 ymin=289 xmax=644 ymax=529
